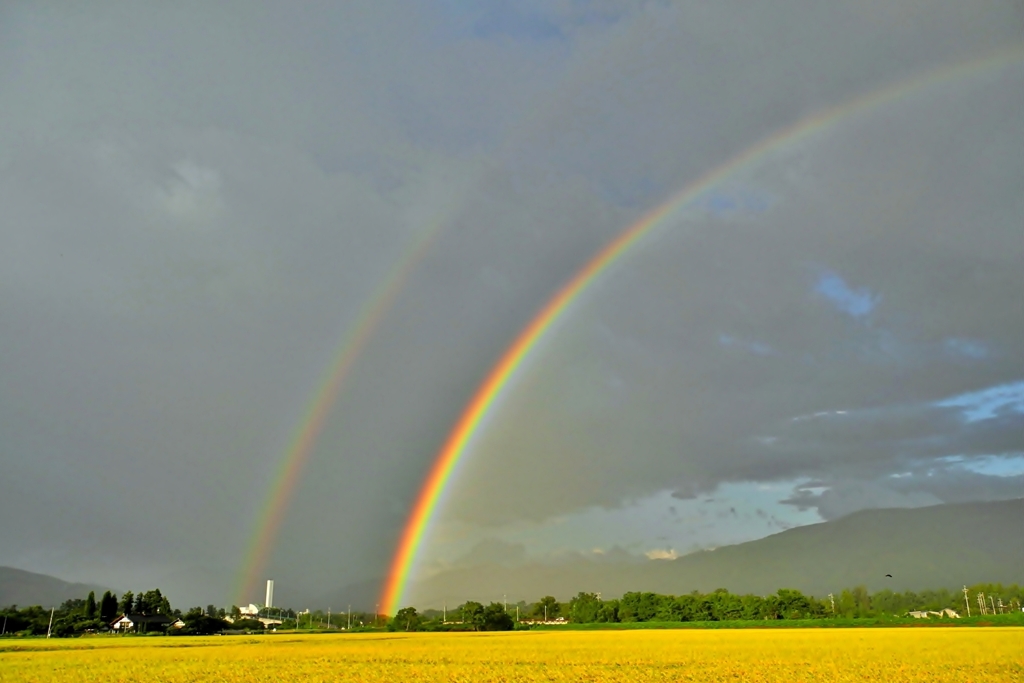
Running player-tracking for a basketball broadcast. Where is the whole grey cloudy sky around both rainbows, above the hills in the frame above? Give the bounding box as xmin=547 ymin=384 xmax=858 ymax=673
xmin=0 ymin=0 xmax=1024 ymax=606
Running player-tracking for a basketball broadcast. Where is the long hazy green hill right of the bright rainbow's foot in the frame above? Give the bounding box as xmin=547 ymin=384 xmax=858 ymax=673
xmin=411 ymin=499 xmax=1024 ymax=607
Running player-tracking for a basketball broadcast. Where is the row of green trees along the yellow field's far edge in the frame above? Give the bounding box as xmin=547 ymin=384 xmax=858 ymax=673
xmin=0 ymin=584 xmax=1024 ymax=637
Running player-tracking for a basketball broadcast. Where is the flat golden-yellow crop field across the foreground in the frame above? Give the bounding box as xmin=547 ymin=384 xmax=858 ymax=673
xmin=0 ymin=628 xmax=1024 ymax=683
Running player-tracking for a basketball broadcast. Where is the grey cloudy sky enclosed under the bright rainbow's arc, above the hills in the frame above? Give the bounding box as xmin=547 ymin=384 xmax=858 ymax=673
xmin=442 ymin=22 xmax=1024 ymax=523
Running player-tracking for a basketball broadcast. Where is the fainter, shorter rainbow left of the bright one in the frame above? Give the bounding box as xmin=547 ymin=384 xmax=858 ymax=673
xmin=236 ymin=218 xmax=444 ymax=604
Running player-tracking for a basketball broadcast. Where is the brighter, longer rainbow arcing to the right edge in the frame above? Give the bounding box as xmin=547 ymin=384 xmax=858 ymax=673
xmin=380 ymin=46 xmax=1024 ymax=614
